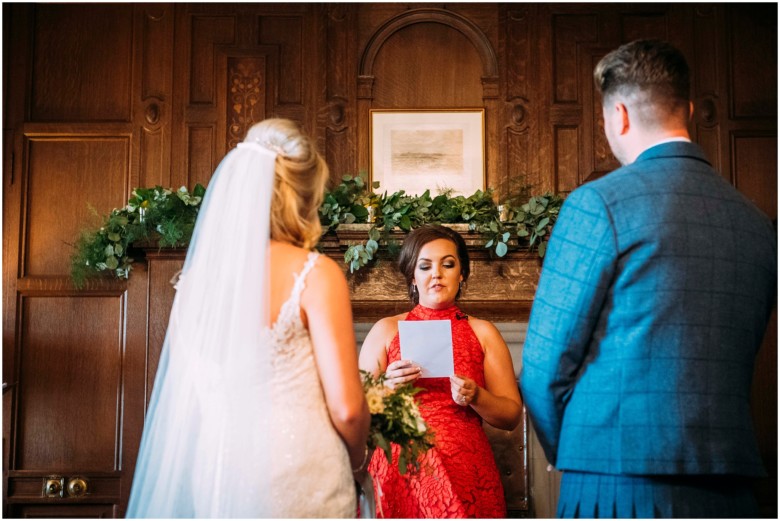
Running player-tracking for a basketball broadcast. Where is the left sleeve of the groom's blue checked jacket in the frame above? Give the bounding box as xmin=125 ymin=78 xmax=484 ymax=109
xmin=520 ymin=186 xmax=617 ymax=465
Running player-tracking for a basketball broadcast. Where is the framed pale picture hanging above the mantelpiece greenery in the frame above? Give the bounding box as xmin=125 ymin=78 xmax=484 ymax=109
xmin=370 ymin=109 xmax=485 ymax=196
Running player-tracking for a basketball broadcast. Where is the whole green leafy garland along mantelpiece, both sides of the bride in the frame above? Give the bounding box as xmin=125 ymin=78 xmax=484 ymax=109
xmin=71 ymin=175 xmax=563 ymax=287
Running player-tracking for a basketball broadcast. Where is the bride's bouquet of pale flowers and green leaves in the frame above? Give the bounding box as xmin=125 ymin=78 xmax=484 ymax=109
xmin=360 ymin=370 xmax=434 ymax=474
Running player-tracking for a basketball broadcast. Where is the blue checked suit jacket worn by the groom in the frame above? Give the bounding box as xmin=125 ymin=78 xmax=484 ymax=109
xmin=520 ymin=142 xmax=777 ymax=476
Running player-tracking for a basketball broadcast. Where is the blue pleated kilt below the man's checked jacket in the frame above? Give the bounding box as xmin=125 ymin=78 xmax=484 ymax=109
xmin=557 ymin=471 xmax=759 ymax=518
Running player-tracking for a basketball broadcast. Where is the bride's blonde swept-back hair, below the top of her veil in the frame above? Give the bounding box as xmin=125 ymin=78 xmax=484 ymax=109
xmin=245 ymin=118 xmax=329 ymax=249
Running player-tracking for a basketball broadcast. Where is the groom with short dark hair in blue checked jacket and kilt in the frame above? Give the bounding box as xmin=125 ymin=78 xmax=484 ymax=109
xmin=520 ymin=40 xmax=777 ymax=517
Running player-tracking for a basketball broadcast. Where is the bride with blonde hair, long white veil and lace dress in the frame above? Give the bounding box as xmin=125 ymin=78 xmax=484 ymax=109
xmin=127 ymin=119 xmax=369 ymax=518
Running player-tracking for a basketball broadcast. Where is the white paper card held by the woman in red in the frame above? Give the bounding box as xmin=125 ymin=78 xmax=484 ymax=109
xmin=398 ymin=320 xmax=455 ymax=378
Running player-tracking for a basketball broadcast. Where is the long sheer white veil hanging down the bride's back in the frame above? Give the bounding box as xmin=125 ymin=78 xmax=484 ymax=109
xmin=126 ymin=142 xmax=276 ymax=518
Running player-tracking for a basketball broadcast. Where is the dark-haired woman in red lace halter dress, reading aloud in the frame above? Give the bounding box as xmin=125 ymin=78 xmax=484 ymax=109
xmin=360 ymin=226 xmax=522 ymax=518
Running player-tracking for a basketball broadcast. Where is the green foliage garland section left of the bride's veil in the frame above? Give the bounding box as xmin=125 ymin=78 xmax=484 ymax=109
xmin=71 ymin=184 xmax=206 ymax=287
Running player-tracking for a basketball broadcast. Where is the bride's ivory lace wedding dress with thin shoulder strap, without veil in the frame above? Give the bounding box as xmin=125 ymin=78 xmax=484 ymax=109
xmin=266 ymin=253 xmax=356 ymax=518
